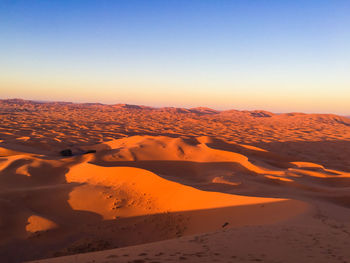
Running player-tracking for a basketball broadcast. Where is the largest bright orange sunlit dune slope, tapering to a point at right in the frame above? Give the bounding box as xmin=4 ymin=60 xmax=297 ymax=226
xmin=66 ymin=164 xmax=304 ymax=219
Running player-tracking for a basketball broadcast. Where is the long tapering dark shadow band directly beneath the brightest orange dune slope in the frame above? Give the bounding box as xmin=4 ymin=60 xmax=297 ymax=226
xmin=9 ymin=200 xmax=306 ymax=262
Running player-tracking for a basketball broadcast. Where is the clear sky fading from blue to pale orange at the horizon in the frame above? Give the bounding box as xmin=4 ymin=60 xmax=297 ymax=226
xmin=0 ymin=0 xmax=350 ymax=115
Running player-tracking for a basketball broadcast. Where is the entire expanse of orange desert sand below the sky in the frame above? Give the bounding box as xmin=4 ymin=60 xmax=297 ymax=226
xmin=0 ymin=100 xmax=350 ymax=263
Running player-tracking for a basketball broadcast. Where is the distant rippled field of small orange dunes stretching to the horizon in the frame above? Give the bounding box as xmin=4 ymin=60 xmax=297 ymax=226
xmin=0 ymin=100 xmax=350 ymax=171
